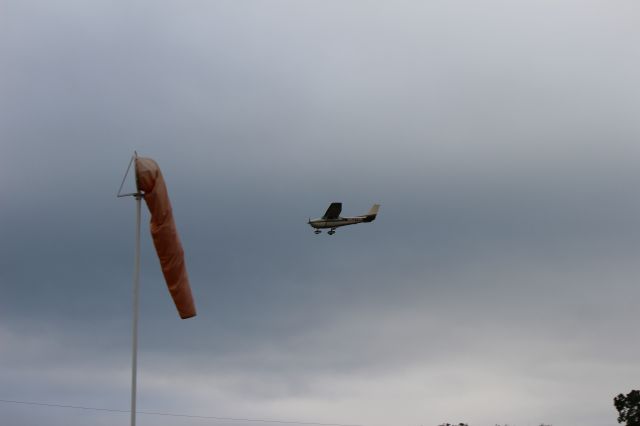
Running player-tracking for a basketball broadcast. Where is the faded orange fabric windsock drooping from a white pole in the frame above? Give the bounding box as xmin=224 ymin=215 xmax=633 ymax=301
xmin=136 ymin=157 xmax=196 ymax=319
